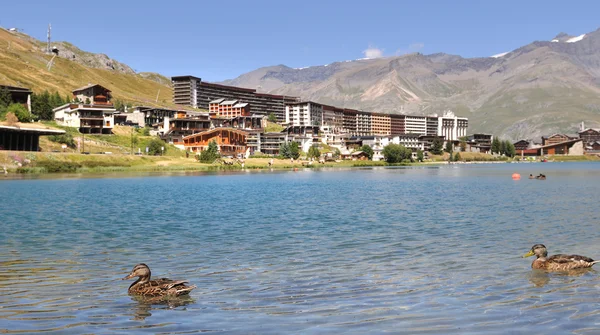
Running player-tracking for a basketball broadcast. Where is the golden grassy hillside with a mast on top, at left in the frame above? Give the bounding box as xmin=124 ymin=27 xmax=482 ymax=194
xmin=0 ymin=28 xmax=174 ymax=106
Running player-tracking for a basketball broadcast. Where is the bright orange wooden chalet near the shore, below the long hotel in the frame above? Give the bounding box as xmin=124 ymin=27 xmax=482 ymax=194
xmin=183 ymin=128 xmax=248 ymax=156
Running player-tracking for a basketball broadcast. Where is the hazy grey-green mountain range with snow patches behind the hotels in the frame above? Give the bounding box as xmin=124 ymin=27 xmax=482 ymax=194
xmin=223 ymin=30 xmax=600 ymax=139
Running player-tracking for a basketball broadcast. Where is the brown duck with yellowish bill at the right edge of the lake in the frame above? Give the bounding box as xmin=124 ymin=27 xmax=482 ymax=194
xmin=523 ymin=244 xmax=600 ymax=271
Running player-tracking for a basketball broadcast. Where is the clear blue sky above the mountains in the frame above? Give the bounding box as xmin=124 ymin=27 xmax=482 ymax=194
xmin=0 ymin=0 xmax=600 ymax=81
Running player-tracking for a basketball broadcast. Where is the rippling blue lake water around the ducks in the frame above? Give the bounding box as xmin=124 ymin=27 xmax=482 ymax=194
xmin=0 ymin=163 xmax=600 ymax=334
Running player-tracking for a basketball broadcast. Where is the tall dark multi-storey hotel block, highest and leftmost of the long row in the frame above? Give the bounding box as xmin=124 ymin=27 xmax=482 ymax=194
xmin=171 ymin=76 xmax=299 ymax=122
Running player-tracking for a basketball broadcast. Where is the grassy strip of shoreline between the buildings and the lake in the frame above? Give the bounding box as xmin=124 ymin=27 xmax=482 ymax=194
xmin=0 ymin=151 xmax=600 ymax=179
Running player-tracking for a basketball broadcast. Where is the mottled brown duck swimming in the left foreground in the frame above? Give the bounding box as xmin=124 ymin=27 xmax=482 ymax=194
xmin=122 ymin=263 xmax=196 ymax=297
